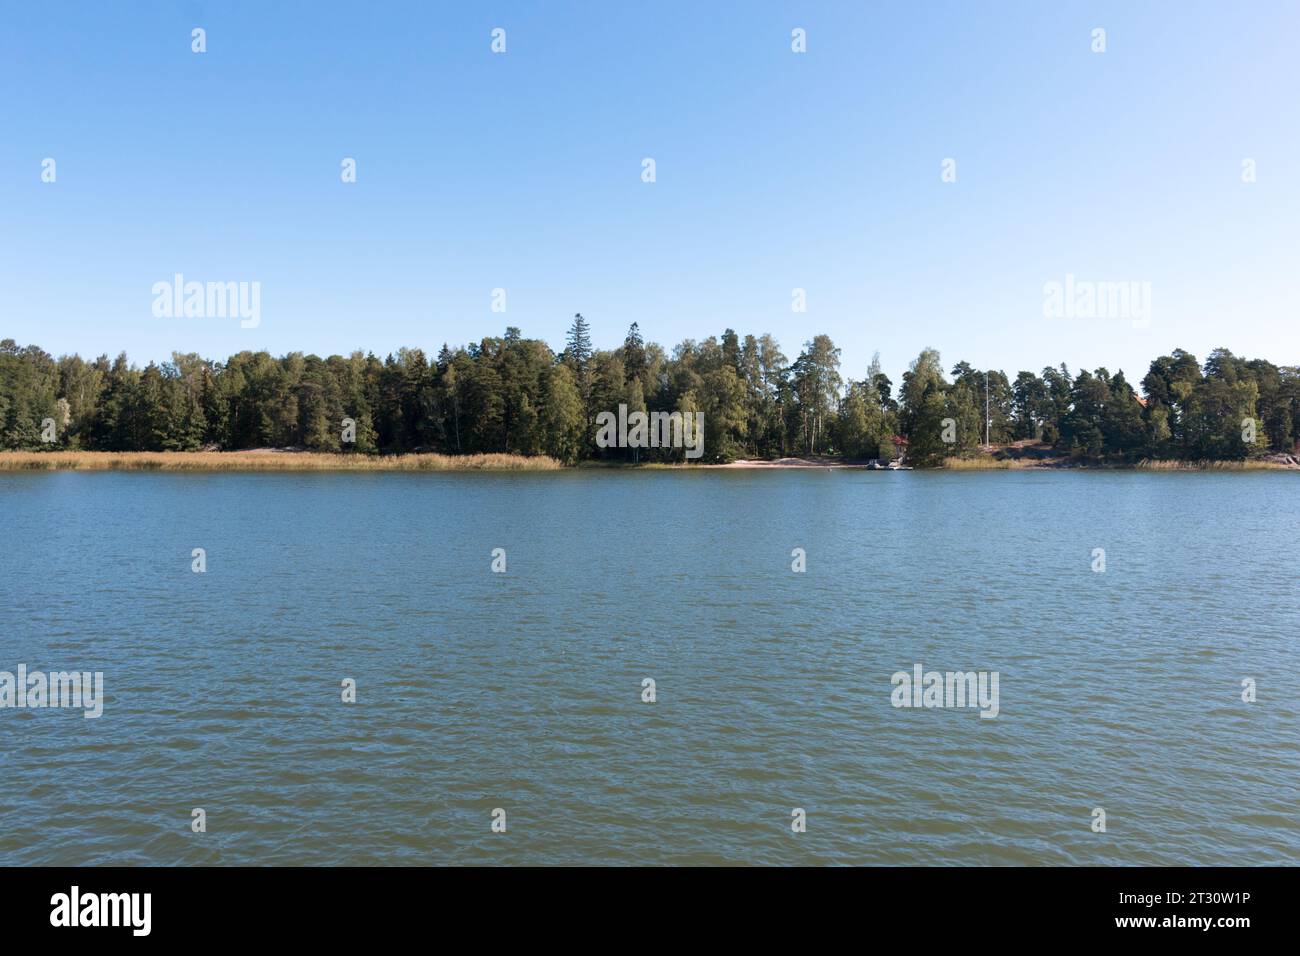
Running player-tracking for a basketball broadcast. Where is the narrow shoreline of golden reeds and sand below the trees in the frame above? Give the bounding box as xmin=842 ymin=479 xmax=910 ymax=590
xmin=0 ymin=449 xmax=1300 ymax=472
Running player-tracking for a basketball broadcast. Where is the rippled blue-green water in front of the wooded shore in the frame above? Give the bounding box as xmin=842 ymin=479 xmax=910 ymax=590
xmin=0 ymin=471 xmax=1300 ymax=865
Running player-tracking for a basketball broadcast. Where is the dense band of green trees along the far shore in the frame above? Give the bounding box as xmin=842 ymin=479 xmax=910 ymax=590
xmin=0 ymin=315 xmax=1300 ymax=466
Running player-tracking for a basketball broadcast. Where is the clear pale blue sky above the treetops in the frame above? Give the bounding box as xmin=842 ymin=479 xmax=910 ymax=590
xmin=0 ymin=0 xmax=1300 ymax=381
